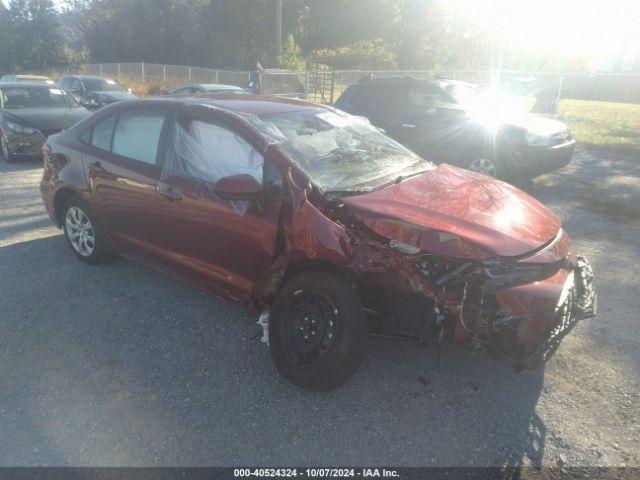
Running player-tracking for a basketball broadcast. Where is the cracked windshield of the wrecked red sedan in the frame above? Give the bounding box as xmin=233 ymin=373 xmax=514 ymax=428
xmin=250 ymin=108 xmax=434 ymax=192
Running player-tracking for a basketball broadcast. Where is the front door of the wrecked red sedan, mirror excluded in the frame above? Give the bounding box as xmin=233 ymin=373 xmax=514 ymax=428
xmin=152 ymin=113 xmax=283 ymax=298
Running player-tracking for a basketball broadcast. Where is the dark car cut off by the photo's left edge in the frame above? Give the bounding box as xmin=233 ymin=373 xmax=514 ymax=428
xmin=0 ymin=82 xmax=91 ymax=162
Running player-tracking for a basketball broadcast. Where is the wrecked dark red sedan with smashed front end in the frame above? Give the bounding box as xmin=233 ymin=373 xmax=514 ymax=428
xmin=41 ymin=95 xmax=595 ymax=390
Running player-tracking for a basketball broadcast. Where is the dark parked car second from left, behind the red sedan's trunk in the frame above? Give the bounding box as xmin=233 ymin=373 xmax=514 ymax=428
xmin=58 ymin=75 xmax=138 ymax=110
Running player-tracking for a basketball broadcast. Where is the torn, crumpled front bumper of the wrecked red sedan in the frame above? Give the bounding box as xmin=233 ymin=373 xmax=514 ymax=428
xmin=496 ymin=257 xmax=597 ymax=365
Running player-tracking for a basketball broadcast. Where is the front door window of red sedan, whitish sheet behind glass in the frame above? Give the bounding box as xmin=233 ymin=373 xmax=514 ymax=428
xmin=168 ymin=119 xmax=264 ymax=185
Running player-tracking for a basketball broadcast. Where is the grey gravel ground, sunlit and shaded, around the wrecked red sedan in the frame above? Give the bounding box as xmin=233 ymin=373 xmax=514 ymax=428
xmin=0 ymin=149 xmax=640 ymax=466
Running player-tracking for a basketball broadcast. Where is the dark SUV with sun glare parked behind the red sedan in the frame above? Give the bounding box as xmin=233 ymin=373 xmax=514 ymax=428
xmin=335 ymin=77 xmax=576 ymax=181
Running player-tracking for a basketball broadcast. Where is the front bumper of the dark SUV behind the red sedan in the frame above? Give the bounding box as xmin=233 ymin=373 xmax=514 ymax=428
xmin=511 ymin=140 xmax=576 ymax=178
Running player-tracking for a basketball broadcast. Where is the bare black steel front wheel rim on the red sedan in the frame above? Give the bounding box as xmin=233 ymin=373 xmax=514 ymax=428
xmin=285 ymin=291 xmax=339 ymax=368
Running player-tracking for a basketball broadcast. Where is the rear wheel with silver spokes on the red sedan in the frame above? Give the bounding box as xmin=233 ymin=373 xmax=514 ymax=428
xmin=62 ymin=196 xmax=108 ymax=264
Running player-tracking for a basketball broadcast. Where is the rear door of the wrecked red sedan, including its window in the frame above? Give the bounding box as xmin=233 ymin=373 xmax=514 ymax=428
xmin=81 ymin=108 xmax=169 ymax=260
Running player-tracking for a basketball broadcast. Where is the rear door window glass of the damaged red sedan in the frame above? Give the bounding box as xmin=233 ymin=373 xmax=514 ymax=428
xmin=112 ymin=110 xmax=167 ymax=164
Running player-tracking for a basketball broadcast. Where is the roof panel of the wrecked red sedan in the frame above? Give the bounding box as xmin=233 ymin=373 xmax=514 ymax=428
xmin=129 ymin=94 xmax=327 ymax=116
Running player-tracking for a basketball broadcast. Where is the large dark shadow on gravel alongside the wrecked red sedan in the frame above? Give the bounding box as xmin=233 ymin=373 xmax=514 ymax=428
xmin=0 ymin=236 xmax=546 ymax=466
